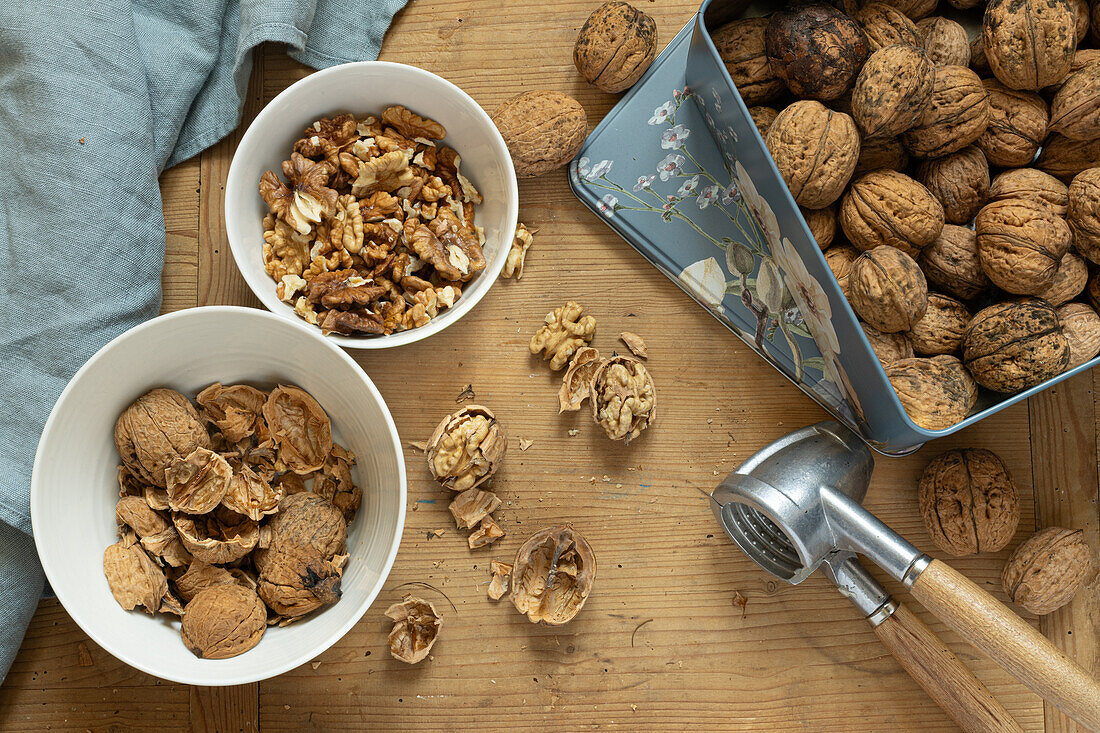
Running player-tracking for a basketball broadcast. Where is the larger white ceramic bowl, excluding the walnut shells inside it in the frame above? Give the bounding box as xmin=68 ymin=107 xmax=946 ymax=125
xmin=31 ymin=306 xmax=405 ymax=686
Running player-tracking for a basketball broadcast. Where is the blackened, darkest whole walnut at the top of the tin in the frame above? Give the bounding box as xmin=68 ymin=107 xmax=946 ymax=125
xmin=765 ymin=2 xmax=871 ymax=99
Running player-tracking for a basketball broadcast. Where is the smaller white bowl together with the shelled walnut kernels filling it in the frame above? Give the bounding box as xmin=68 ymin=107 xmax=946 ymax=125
xmin=226 ymin=62 xmax=518 ymax=349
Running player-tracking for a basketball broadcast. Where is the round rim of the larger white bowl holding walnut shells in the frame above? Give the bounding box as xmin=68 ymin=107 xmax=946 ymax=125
xmin=31 ymin=306 xmax=408 ymax=687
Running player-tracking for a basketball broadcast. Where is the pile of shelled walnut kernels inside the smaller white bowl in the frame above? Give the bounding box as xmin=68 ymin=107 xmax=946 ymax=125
xmin=260 ymin=106 xmax=486 ymax=335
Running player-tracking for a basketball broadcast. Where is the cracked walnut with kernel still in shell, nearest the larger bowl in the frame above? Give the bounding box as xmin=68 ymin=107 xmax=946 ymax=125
xmin=428 ymin=405 xmax=508 ymax=491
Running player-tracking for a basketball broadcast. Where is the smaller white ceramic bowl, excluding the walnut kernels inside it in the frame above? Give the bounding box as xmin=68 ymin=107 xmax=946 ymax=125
xmin=226 ymin=62 xmax=519 ymax=349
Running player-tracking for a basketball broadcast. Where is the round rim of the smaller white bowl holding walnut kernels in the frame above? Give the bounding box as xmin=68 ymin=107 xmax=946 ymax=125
xmin=223 ymin=61 xmax=519 ymax=349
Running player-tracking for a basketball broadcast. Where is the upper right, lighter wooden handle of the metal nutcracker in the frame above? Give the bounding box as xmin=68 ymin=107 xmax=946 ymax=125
xmin=912 ymin=560 xmax=1100 ymax=731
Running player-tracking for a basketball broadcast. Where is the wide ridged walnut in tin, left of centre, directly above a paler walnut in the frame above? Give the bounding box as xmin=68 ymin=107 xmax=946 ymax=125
xmin=838 ymin=171 xmax=944 ymax=256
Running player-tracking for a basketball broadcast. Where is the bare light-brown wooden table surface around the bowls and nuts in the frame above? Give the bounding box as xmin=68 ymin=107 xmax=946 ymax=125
xmin=0 ymin=0 xmax=1100 ymax=732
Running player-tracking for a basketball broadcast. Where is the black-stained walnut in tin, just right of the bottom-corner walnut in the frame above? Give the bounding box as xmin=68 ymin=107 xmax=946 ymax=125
xmin=963 ymin=298 xmax=1069 ymax=394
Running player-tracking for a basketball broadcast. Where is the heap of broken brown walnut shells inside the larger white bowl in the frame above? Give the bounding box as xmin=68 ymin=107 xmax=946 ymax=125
xmin=103 ymin=383 xmax=362 ymax=659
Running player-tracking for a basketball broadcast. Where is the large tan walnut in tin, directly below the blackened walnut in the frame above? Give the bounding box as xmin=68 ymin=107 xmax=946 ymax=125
xmin=765 ymin=100 xmax=859 ymax=209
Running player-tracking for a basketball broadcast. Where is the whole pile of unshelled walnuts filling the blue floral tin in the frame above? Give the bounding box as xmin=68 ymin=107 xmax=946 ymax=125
xmin=712 ymin=0 xmax=1100 ymax=429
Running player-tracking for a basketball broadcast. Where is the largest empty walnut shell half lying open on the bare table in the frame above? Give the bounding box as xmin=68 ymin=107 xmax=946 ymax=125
xmin=512 ymin=524 xmax=596 ymax=626
